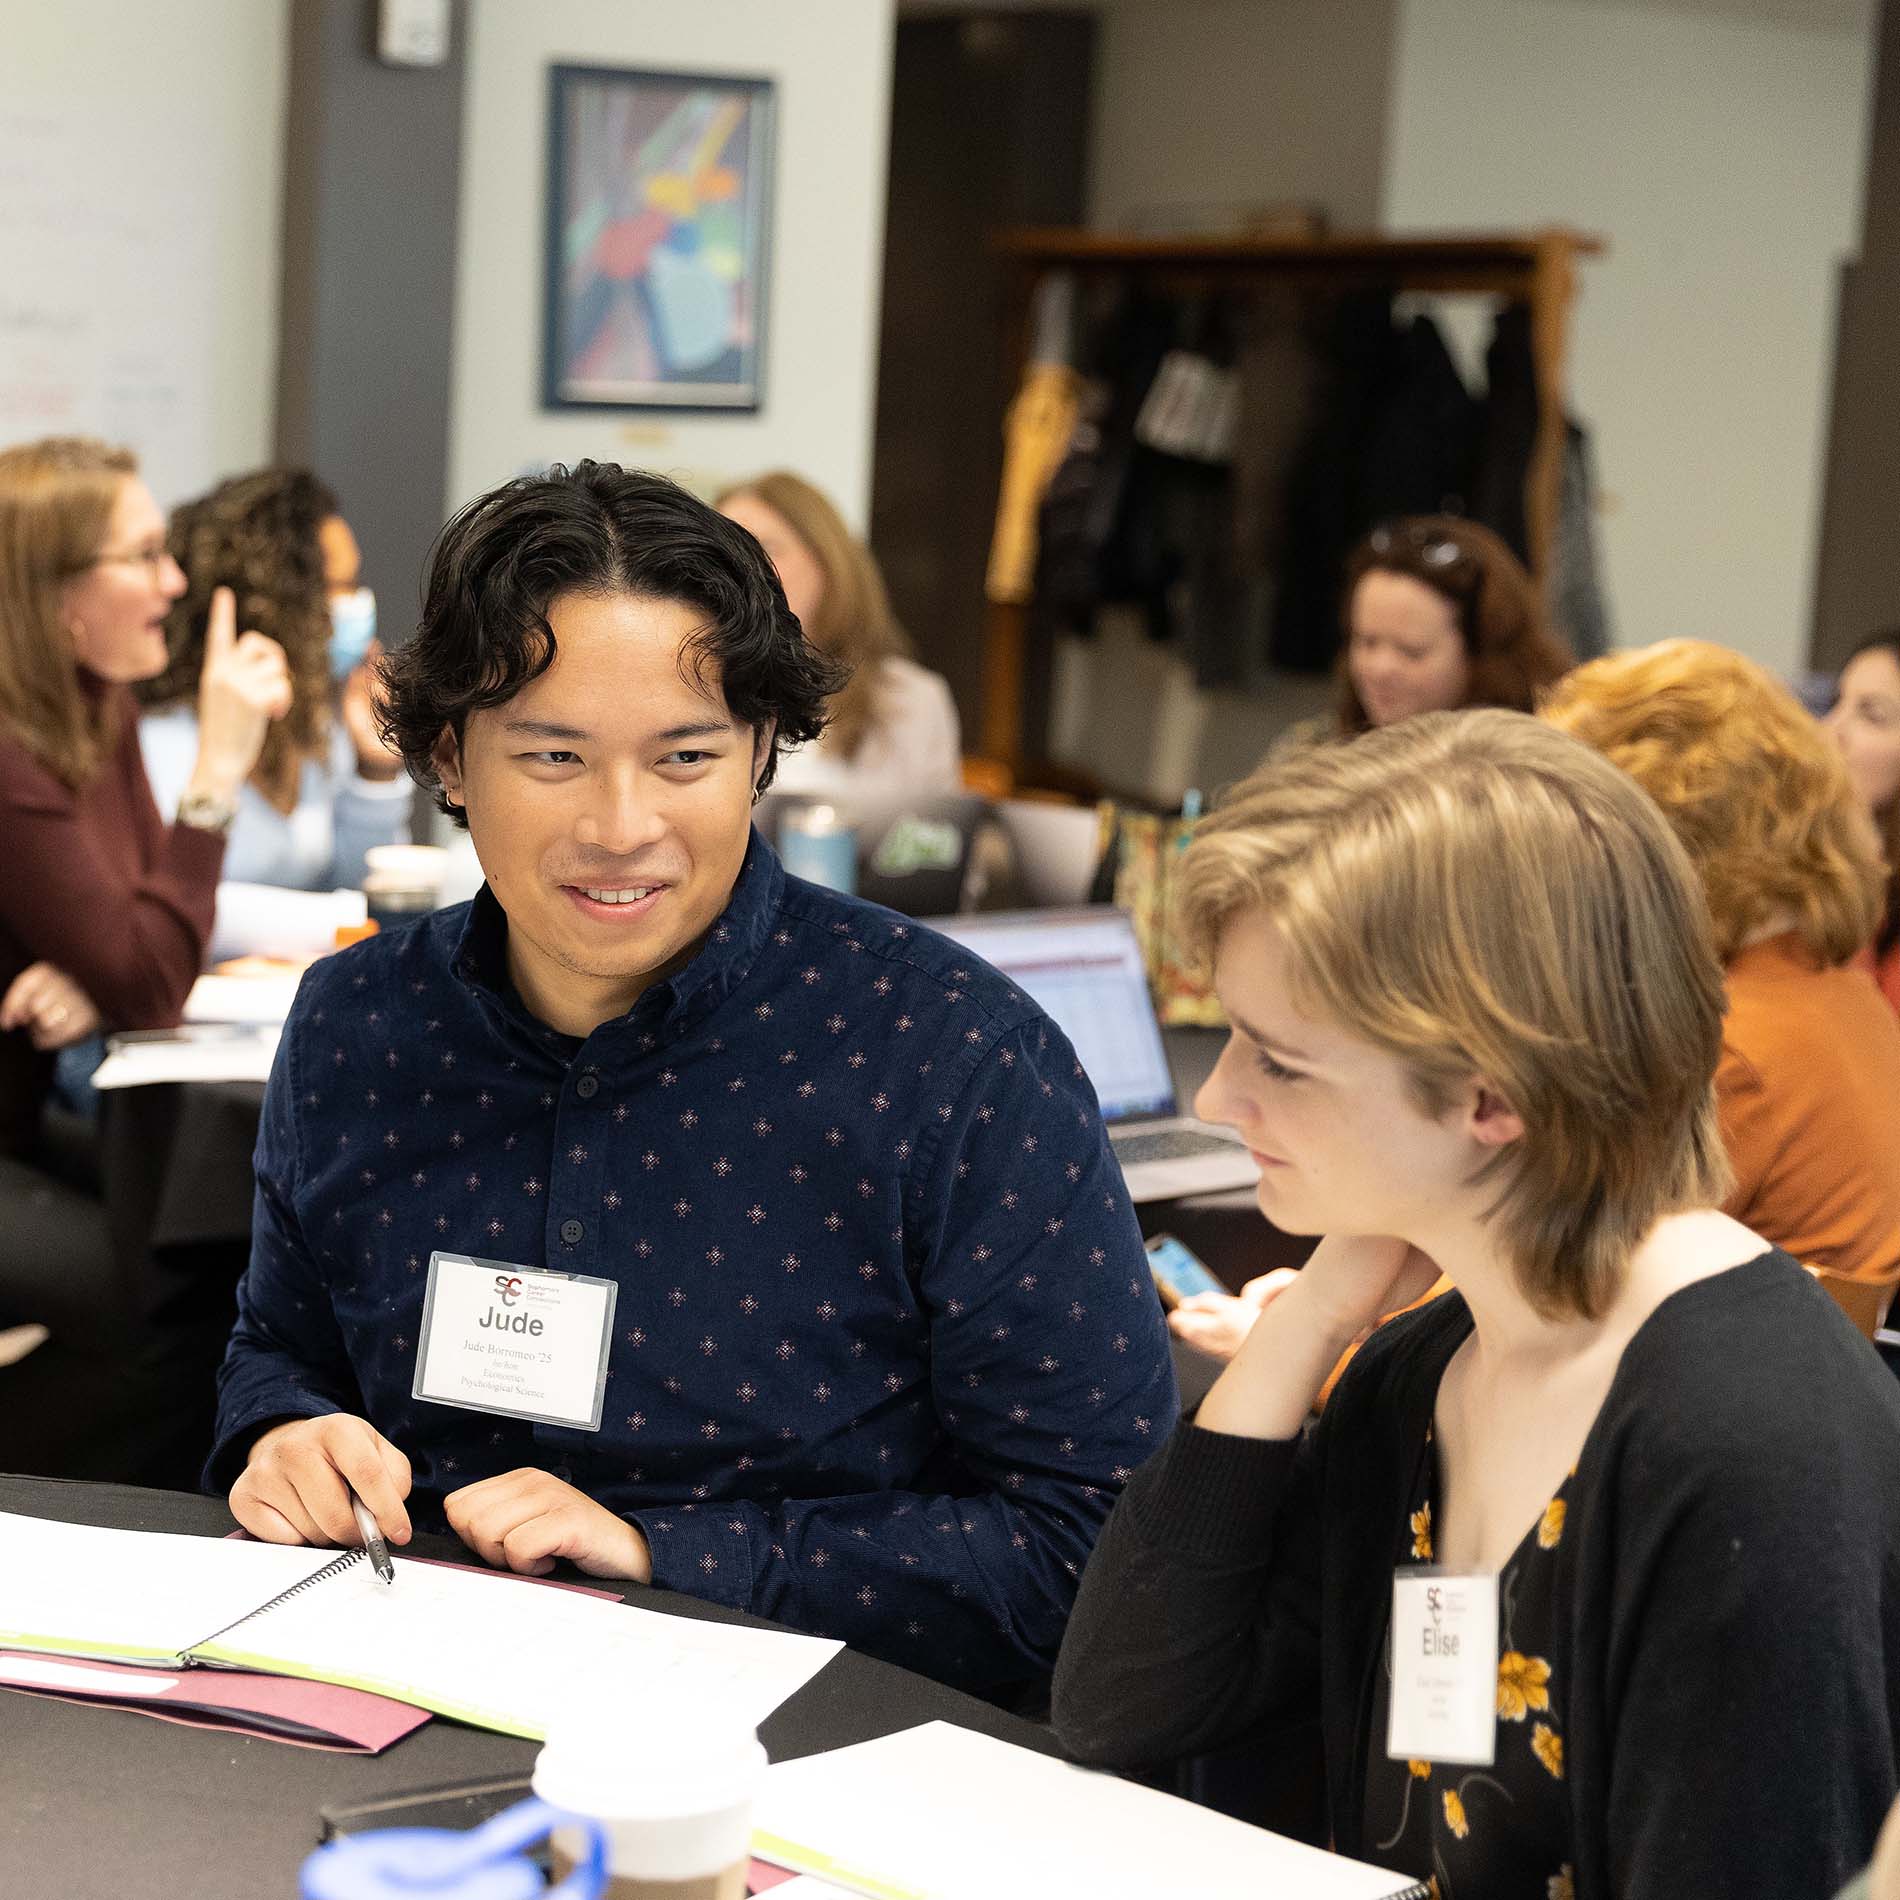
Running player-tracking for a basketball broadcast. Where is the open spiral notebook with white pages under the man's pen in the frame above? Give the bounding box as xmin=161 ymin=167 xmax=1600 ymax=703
xmin=0 ymin=1512 xmax=844 ymax=1740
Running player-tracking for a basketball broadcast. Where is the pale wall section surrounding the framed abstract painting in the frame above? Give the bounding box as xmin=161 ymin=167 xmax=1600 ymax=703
xmin=448 ymin=0 xmax=893 ymax=524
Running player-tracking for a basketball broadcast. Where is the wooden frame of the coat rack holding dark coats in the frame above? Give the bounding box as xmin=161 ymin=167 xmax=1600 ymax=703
xmin=982 ymin=228 xmax=1604 ymax=773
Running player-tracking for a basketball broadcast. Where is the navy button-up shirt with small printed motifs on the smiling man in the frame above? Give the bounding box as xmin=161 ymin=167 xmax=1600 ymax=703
xmin=207 ymin=834 xmax=1176 ymax=1689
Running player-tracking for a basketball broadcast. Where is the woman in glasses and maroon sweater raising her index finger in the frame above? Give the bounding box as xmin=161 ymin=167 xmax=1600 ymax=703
xmin=0 ymin=437 xmax=291 ymax=1155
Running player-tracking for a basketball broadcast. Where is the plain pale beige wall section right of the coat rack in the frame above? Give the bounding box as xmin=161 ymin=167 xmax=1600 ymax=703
xmin=1385 ymin=0 xmax=1872 ymax=669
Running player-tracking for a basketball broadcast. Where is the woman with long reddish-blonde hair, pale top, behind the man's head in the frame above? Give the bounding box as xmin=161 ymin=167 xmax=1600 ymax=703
xmin=716 ymin=469 xmax=963 ymax=802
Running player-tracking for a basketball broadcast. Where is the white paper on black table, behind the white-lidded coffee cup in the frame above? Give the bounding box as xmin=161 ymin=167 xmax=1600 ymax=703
xmin=752 ymin=1721 xmax=1412 ymax=1900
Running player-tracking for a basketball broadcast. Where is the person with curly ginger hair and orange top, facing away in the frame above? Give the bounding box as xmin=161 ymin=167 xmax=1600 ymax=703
xmin=1543 ymin=640 xmax=1900 ymax=1334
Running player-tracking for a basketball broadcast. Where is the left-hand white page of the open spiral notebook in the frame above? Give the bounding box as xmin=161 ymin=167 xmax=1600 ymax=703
xmin=0 ymin=1511 xmax=336 ymax=1661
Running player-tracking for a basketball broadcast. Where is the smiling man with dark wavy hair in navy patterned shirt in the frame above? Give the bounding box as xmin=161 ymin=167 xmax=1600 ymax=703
xmin=207 ymin=462 xmax=1176 ymax=1693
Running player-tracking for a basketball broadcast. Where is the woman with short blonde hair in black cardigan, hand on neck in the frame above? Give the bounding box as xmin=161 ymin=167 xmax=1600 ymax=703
xmin=1055 ymin=711 xmax=1900 ymax=1900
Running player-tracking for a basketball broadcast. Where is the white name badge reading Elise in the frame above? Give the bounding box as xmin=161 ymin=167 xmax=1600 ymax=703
xmin=1385 ymin=1569 xmax=1497 ymax=1767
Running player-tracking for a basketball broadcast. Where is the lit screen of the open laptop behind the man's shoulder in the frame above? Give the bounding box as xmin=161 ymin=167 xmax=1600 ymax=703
xmin=931 ymin=904 xmax=1174 ymax=1121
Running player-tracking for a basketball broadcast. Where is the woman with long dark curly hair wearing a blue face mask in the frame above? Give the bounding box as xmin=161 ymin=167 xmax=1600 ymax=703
xmin=139 ymin=469 xmax=410 ymax=923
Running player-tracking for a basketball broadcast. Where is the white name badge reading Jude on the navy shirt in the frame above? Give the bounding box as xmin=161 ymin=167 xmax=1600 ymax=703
xmin=410 ymin=1254 xmax=619 ymax=1431
